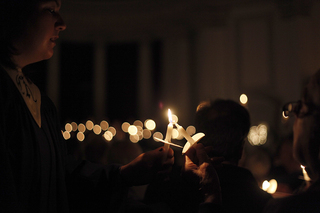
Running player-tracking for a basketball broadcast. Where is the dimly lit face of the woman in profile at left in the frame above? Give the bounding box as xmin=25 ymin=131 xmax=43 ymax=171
xmin=14 ymin=0 xmax=66 ymax=68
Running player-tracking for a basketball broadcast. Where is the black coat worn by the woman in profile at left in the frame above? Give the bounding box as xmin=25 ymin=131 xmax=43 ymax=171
xmin=0 ymin=66 xmax=127 ymax=212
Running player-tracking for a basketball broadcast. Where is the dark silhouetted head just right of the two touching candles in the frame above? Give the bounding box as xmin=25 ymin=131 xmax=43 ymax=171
xmin=195 ymin=99 xmax=250 ymax=162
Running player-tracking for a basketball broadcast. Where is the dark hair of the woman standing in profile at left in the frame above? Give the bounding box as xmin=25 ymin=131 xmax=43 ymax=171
xmin=0 ymin=0 xmax=53 ymax=69
